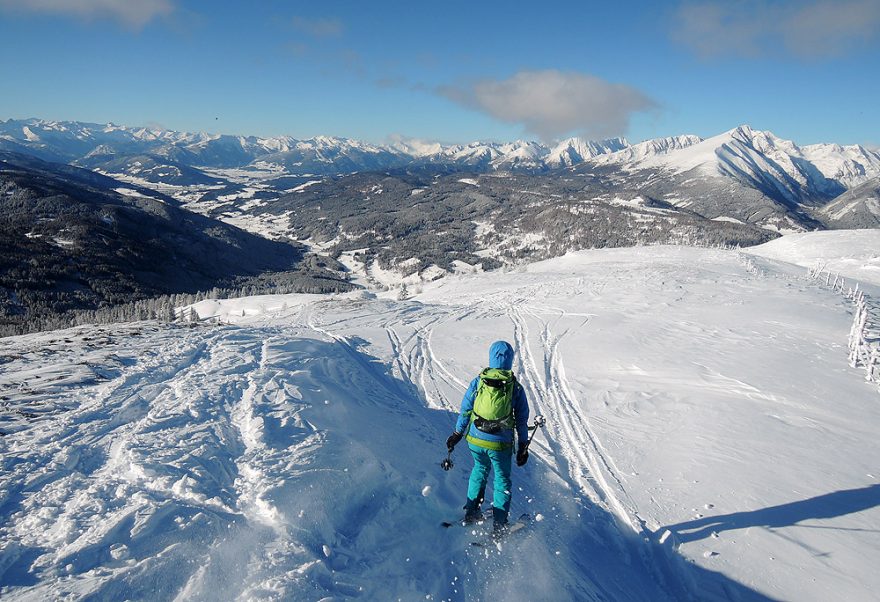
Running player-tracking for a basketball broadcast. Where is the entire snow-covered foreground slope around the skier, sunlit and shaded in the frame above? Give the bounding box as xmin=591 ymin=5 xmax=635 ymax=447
xmin=0 ymin=233 xmax=880 ymax=600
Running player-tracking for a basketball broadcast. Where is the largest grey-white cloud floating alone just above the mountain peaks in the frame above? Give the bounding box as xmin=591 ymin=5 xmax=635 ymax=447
xmin=438 ymin=70 xmax=656 ymax=140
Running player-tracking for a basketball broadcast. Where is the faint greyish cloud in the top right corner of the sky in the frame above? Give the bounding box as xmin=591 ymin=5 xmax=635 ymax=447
xmin=671 ymin=0 xmax=880 ymax=58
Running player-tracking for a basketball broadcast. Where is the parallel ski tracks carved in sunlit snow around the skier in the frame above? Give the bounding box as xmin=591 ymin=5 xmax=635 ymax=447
xmin=372 ymin=288 xmax=691 ymax=598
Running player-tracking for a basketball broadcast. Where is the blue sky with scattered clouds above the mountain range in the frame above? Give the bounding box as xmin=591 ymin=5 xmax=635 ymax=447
xmin=0 ymin=0 xmax=880 ymax=145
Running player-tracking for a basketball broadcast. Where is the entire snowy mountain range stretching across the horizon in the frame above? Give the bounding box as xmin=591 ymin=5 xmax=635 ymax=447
xmin=0 ymin=119 xmax=880 ymax=232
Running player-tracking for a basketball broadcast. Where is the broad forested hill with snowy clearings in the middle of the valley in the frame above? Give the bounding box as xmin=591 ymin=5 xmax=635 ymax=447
xmin=241 ymin=173 xmax=776 ymax=279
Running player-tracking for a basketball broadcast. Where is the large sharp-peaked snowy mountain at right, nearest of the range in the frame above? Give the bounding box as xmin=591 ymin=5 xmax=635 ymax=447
xmin=556 ymin=125 xmax=880 ymax=231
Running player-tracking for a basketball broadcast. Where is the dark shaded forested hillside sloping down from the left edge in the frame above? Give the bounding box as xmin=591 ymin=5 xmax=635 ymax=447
xmin=0 ymin=152 xmax=334 ymax=326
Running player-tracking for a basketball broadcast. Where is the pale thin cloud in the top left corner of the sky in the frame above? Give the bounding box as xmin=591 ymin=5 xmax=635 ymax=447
xmin=0 ymin=0 xmax=174 ymax=29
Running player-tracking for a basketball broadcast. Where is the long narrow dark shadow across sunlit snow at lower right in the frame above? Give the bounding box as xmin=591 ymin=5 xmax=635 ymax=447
xmin=658 ymin=483 xmax=880 ymax=543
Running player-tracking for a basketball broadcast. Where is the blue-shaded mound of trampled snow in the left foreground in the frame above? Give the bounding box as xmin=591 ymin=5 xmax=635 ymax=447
xmin=3 ymin=302 xmax=748 ymax=600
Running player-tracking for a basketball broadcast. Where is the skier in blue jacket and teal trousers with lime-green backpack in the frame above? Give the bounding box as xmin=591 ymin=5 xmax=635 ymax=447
xmin=446 ymin=341 xmax=529 ymax=534
